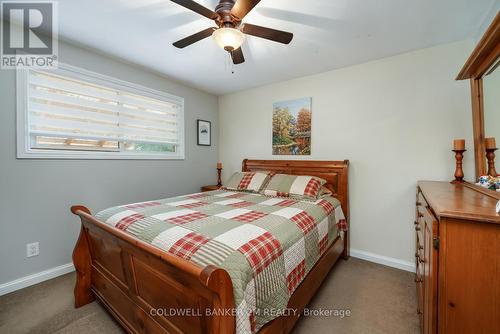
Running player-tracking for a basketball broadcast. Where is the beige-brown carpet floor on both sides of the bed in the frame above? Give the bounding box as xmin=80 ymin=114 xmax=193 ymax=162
xmin=0 ymin=258 xmax=419 ymax=334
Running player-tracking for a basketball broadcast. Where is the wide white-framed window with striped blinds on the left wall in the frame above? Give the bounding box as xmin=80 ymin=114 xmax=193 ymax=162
xmin=17 ymin=64 xmax=184 ymax=159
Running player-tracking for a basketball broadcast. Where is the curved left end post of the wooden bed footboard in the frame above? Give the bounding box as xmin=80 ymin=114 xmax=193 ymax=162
xmin=71 ymin=205 xmax=95 ymax=308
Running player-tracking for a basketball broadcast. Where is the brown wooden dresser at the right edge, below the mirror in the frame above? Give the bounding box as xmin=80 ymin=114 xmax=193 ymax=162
xmin=415 ymin=181 xmax=500 ymax=334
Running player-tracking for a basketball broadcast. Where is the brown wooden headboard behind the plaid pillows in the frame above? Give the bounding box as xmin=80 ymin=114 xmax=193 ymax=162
xmin=242 ymin=159 xmax=349 ymax=221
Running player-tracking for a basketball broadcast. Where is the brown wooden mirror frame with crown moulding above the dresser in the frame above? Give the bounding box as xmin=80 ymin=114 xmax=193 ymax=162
xmin=456 ymin=12 xmax=500 ymax=181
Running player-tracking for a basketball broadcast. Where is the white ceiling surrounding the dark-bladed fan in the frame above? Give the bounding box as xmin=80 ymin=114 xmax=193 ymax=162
xmin=59 ymin=0 xmax=495 ymax=94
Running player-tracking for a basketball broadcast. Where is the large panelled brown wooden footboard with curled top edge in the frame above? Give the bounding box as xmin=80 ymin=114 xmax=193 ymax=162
xmin=71 ymin=206 xmax=235 ymax=333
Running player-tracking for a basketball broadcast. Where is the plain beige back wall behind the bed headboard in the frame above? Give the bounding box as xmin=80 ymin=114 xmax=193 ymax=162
xmin=219 ymin=41 xmax=474 ymax=264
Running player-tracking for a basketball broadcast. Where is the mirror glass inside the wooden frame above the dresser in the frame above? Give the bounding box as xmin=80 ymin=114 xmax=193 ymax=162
xmin=483 ymin=61 xmax=500 ymax=153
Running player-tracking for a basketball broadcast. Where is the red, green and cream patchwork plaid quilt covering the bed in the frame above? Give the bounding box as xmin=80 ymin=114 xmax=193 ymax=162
xmin=96 ymin=190 xmax=347 ymax=333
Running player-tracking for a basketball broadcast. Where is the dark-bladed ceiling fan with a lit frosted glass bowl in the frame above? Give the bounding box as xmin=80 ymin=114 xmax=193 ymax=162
xmin=170 ymin=0 xmax=293 ymax=64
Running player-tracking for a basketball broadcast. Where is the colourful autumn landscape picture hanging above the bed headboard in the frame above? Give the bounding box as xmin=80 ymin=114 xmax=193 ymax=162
xmin=273 ymin=97 xmax=312 ymax=155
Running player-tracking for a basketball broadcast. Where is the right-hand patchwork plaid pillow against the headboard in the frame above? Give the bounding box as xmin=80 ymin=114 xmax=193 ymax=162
xmin=262 ymin=174 xmax=326 ymax=199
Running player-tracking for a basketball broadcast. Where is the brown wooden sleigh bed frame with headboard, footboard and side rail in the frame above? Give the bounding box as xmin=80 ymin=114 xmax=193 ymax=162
xmin=71 ymin=160 xmax=349 ymax=334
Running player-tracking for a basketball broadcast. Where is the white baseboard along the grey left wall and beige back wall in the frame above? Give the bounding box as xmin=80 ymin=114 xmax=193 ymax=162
xmin=0 ymin=248 xmax=415 ymax=296
